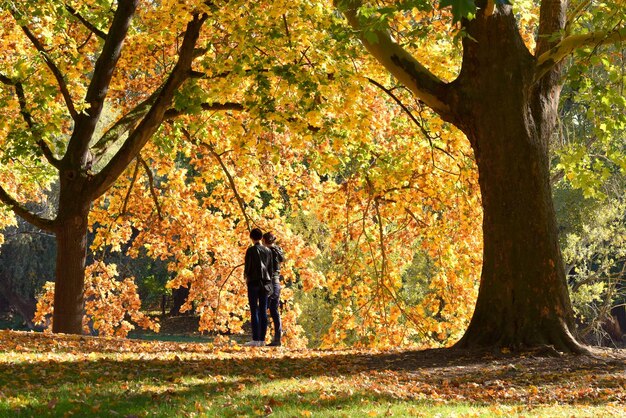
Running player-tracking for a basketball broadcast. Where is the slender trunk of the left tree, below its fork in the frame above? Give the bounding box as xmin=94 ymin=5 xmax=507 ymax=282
xmin=52 ymin=179 xmax=90 ymax=334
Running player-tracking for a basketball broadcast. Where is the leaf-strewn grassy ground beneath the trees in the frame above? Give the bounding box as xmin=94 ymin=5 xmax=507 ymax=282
xmin=0 ymin=331 xmax=626 ymax=418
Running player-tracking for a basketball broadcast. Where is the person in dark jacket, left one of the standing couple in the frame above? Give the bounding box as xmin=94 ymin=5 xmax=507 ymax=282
xmin=244 ymin=228 xmax=274 ymax=347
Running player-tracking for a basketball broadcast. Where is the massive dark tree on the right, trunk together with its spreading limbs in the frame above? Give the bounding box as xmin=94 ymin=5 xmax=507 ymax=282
xmin=336 ymin=0 xmax=626 ymax=352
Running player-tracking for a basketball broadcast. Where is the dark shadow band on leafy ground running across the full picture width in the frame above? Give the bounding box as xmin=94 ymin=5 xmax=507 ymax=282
xmin=0 ymin=349 xmax=626 ymax=388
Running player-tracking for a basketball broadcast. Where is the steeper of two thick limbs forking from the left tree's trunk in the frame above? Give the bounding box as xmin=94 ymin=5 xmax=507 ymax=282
xmin=64 ymin=0 xmax=139 ymax=163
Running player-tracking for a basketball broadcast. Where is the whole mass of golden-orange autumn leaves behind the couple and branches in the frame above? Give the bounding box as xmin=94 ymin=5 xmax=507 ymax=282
xmin=6 ymin=0 xmax=482 ymax=347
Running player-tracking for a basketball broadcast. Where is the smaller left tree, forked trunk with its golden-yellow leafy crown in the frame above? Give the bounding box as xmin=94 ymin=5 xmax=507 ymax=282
xmin=0 ymin=0 xmax=386 ymax=340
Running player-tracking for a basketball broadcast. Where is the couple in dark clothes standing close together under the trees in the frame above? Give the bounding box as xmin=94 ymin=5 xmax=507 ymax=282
xmin=244 ymin=228 xmax=285 ymax=347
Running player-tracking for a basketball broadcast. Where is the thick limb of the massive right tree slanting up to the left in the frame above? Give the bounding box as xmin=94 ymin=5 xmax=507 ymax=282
xmin=335 ymin=0 xmax=452 ymax=118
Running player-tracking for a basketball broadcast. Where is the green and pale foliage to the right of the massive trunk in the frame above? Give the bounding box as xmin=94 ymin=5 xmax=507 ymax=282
xmin=552 ymin=40 xmax=626 ymax=344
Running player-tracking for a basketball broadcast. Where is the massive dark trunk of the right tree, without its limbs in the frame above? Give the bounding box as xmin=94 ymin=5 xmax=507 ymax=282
xmin=455 ymin=8 xmax=582 ymax=351
